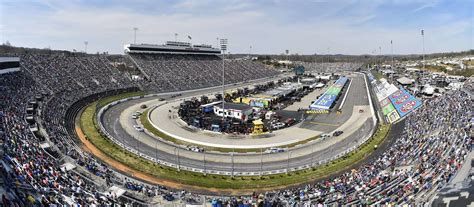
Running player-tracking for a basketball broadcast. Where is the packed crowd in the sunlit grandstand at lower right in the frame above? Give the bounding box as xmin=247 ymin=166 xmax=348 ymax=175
xmin=209 ymin=86 xmax=474 ymax=206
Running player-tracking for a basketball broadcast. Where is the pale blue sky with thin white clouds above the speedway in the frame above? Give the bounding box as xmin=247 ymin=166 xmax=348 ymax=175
xmin=0 ymin=0 xmax=474 ymax=55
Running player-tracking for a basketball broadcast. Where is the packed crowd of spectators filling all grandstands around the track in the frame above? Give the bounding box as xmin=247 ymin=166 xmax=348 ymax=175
xmin=0 ymin=51 xmax=473 ymax=206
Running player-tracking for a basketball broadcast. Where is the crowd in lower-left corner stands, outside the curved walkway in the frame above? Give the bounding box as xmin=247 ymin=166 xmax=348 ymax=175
xmin=0 ymin=72 xmax=121 ymax=206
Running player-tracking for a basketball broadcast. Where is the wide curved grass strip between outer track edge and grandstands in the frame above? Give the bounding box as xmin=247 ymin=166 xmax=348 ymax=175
xmin=80 ymin=92 xmax=390 ymax=190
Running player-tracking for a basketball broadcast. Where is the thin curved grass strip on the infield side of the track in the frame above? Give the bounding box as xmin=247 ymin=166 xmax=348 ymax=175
xmin=140 ymin=109 xmax=320 ymax=153
